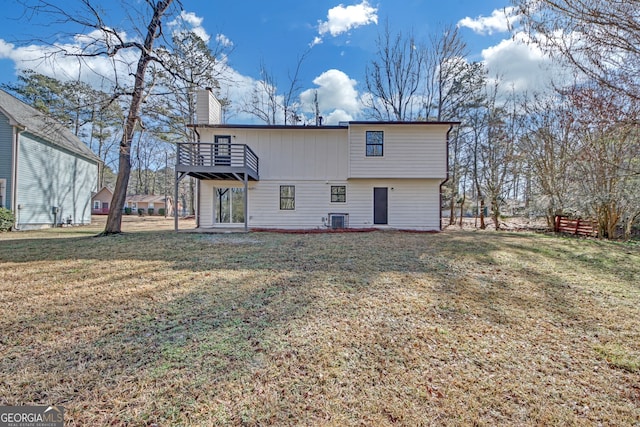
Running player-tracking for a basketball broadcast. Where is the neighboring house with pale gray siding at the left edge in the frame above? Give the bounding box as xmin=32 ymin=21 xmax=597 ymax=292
xmin=0 ymin=90 xmax=101 ymax=230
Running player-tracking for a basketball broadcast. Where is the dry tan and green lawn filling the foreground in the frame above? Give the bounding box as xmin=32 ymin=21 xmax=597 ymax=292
xmin=0 ymin=223 xmax=640 ymax=427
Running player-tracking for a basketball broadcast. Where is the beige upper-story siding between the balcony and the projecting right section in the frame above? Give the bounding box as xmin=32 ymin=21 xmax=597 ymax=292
xmin=199 ymin=128 xmax=348 ymax=181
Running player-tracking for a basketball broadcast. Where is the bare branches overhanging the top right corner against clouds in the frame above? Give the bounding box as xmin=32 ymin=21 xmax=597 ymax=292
xmin=513 ymin=0 xmax=640 ymax=100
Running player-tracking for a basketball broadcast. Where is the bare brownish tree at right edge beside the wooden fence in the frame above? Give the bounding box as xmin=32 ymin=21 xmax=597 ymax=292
xmin=567 ymin=85 xmax=640 ymax=238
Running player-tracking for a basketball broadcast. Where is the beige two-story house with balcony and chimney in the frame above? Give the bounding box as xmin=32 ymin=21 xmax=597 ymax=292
xmin=176 ymin=91 xmax=457 ymax=230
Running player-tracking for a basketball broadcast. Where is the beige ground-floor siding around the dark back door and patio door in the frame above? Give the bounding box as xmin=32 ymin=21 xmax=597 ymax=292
xmin=200 ymin=179 xmax=440 ymax=230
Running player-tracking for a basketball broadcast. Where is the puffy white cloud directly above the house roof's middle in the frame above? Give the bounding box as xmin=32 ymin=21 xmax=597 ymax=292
xmin=300 ymin=69 xmax=361 ymax=124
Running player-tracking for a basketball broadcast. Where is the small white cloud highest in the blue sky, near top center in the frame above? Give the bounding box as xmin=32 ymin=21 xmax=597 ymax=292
xmin=311 ymin=0 xmax=378 ymax=46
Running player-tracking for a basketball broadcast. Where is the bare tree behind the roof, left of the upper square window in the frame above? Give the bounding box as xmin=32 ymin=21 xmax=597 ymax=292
xmin=363 ymin=23 xmax=425 ymax=121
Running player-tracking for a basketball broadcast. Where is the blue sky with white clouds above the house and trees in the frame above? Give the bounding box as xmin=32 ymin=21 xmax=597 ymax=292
xmin=0 ymin=0 xmax=554 ymax=124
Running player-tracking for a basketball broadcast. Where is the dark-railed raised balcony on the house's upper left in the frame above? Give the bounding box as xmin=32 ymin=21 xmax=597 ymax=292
xmin=176 ymin=142 xmax=260 ymax=181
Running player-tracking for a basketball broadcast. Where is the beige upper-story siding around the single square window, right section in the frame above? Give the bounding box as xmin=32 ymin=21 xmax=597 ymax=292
xmin=348 ymin=122 xmax=449 ymax=179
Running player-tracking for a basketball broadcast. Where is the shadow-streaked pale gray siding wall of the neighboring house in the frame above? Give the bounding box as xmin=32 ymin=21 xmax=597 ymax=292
xmin=16 ymin=133 xmax=98 ymax=229
